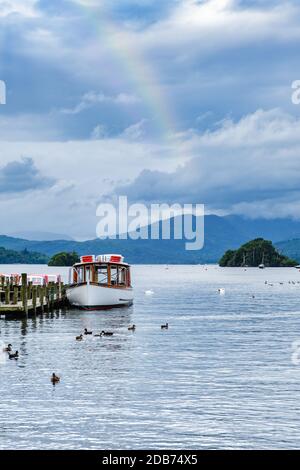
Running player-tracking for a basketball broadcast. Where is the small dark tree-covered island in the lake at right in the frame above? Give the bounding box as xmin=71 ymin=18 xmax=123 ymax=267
xmin=219 ymin=238 xmax=298 ymax=268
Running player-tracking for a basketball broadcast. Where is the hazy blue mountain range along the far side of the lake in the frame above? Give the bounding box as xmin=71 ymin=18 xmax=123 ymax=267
xmin=0 ymin=215 xmax=300 ymax=264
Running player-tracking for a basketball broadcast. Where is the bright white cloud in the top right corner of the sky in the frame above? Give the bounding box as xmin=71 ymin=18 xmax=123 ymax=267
xmin=134 ymin=0 xmax=300 ymax=56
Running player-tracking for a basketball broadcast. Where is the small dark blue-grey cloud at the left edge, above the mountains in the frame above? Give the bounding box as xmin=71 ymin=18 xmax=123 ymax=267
xmin=0 ymin=157 xmax=55 ymax=193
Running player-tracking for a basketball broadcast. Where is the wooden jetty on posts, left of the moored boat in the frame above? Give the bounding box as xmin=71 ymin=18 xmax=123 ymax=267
xmin=0 ymin=273 xmax=67 ymax=318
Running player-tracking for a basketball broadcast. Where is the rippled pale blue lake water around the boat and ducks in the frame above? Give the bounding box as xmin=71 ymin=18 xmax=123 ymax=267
xmin=0 ymin=266 xmax=300 ymax=449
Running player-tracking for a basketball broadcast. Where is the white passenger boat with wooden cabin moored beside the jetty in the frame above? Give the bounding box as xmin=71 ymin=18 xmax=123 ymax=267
xmin=67 ymin=254 xmax=133 ymax=310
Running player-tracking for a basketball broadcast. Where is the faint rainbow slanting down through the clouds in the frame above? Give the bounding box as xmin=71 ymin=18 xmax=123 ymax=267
xmin=72 ymin=0 xmax=177 ymax=138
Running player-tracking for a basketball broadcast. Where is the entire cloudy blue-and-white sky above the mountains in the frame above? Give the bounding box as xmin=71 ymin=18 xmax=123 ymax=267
xmin=0 ymin=0 xmax=300 ymax=239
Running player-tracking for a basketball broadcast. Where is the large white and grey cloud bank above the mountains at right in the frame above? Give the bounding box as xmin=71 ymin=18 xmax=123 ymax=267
xmin=113 ymin=109 xmax=300 ymax=217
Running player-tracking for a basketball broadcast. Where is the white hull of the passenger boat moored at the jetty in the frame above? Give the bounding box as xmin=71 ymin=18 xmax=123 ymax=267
xmin=67 ymin=284 xmax=133 ymax=309
